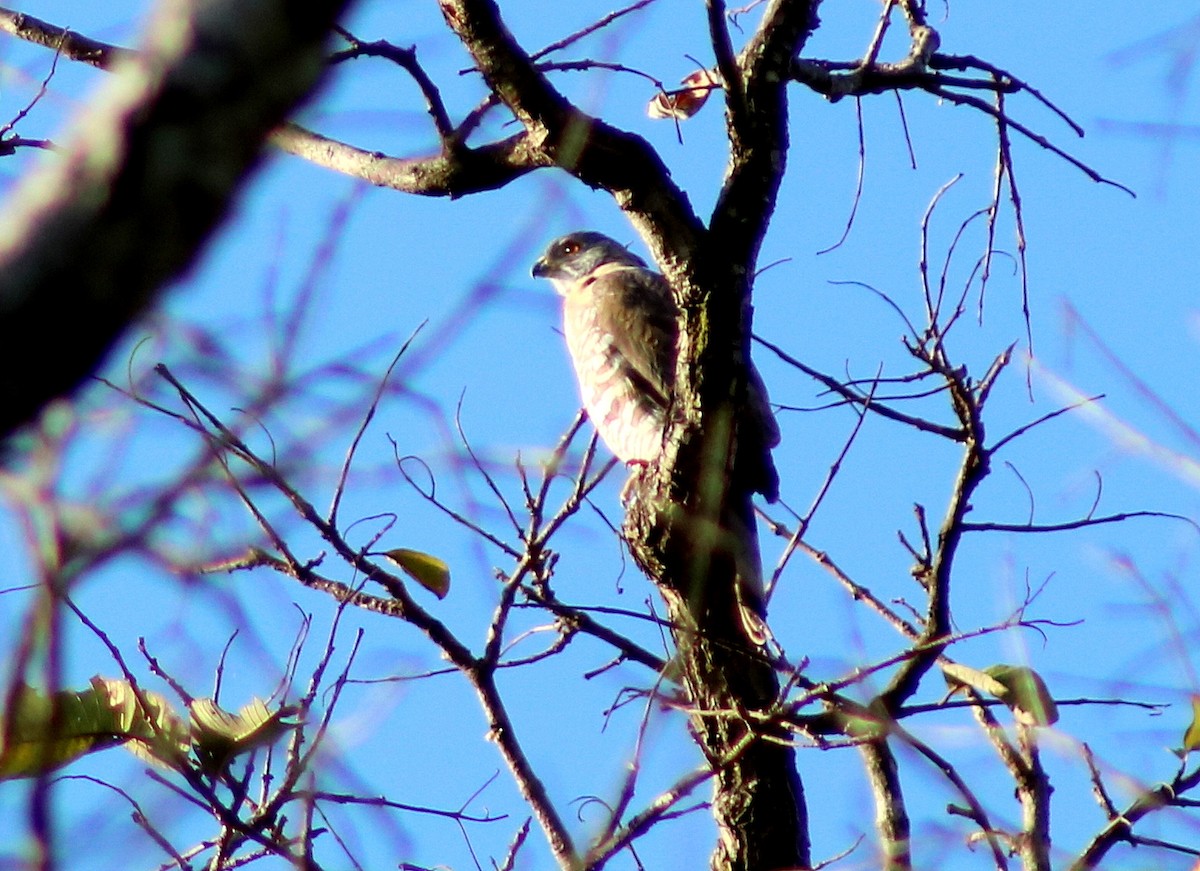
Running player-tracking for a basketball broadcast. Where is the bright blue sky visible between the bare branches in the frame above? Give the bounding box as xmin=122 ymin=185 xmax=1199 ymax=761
xmin=0 ymin=0 xmax=1200 ymax=869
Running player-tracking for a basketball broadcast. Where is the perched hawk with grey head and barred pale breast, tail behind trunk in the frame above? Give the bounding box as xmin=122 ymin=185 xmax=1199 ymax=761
xmin=533 ymin=232 xmax=779 ymax=643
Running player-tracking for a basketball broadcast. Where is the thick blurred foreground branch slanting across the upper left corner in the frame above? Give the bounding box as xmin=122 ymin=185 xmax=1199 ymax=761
xmin=0 ymin=0 xmax=347 ymax=434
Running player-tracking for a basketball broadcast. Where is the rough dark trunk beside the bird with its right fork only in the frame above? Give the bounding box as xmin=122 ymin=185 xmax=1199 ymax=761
xmin=625 ymin=0 xmax=816 ymax=871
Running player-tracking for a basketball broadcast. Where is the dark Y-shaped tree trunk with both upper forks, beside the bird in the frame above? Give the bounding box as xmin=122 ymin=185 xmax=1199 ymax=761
xmin=442 ymin=0 xmax=816 ymax=871
